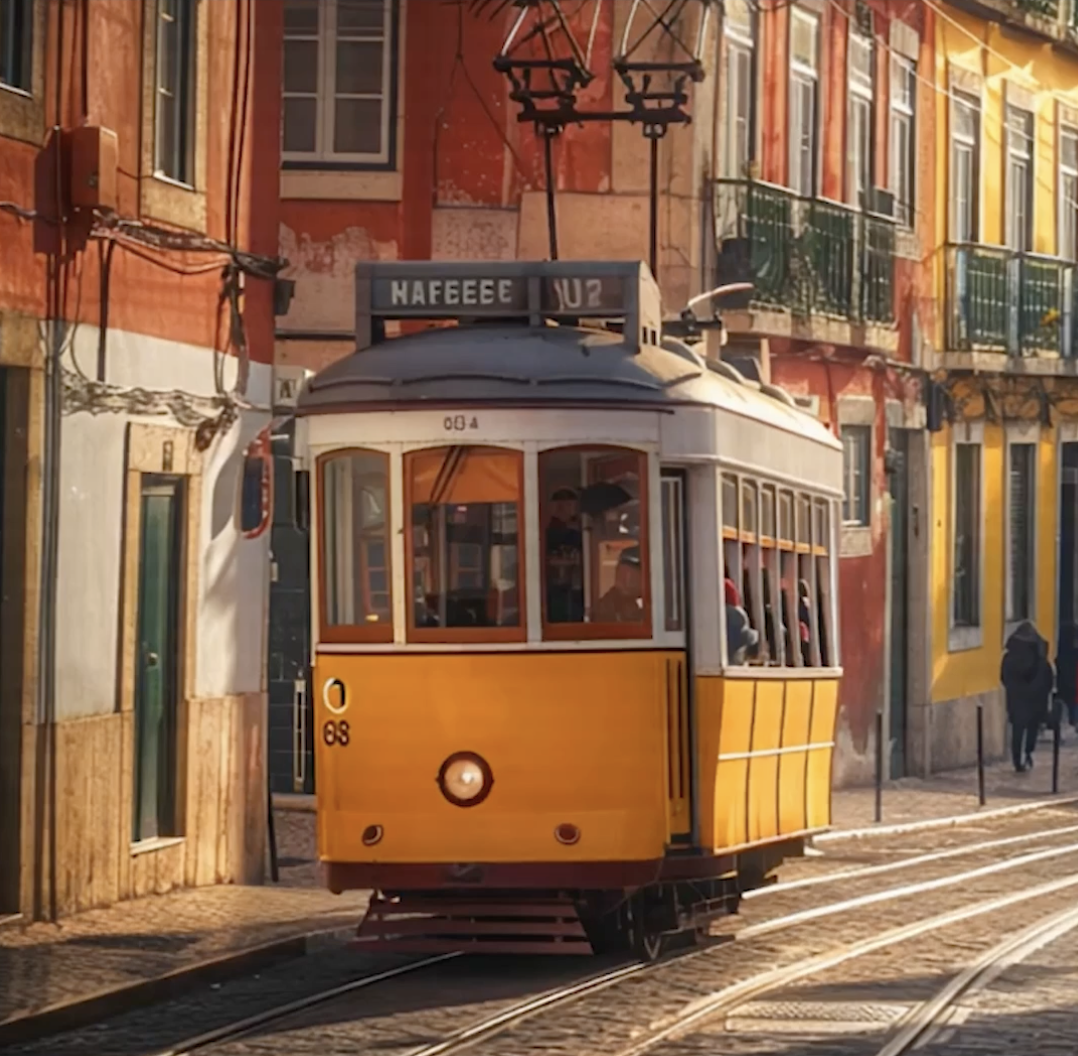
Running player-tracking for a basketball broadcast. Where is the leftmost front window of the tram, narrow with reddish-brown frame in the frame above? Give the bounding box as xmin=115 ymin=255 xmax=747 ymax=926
xmin=319 ymin=450 xmax=393 ymax=642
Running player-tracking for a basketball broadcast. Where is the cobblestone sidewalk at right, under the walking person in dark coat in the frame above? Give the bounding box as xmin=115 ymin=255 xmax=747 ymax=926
xmin=832 ymin=730 xmax=1078 ymax=829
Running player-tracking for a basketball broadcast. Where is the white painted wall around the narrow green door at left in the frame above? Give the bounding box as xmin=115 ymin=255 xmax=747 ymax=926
xmin=56 ymin=324 xmax=272 ymax=720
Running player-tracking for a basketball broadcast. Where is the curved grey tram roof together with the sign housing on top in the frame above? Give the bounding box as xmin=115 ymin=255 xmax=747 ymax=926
xmin=296 ymin=262 xmax=838 ymax=446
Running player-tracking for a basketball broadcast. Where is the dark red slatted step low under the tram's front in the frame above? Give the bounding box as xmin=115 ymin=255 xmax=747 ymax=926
xmin=356 ymin=897 xmax=592 ymax=955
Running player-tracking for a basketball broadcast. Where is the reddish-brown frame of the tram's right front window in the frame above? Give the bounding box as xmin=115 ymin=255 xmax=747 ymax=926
xmin=536 ymin=444 xmax=646 ymax=641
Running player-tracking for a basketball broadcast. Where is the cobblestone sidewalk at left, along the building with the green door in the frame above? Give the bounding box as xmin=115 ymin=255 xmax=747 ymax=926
xmin=0 ymin=811 xmax=367 ymax=1023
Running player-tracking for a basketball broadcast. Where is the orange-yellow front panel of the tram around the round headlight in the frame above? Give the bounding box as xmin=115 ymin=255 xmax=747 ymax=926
xmin=315 ymin=651 xmax=681 ymax=863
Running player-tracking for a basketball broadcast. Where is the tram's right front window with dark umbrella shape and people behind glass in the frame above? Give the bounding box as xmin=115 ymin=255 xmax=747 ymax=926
xmin=539 ymin=447 xmax=651 ymax=640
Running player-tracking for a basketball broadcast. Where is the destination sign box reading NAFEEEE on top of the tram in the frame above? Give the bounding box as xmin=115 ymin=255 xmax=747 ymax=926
xmin=356 ymin=261 xmax=659 ymax=348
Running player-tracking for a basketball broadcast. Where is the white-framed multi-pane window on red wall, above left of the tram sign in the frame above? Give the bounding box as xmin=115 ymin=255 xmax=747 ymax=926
xmin=284 ymin=0 xmax=396 ymax=165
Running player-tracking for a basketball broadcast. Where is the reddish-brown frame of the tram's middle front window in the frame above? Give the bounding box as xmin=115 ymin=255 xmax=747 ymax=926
xmin=402 ymin=444 xmax=528 ymax=644
